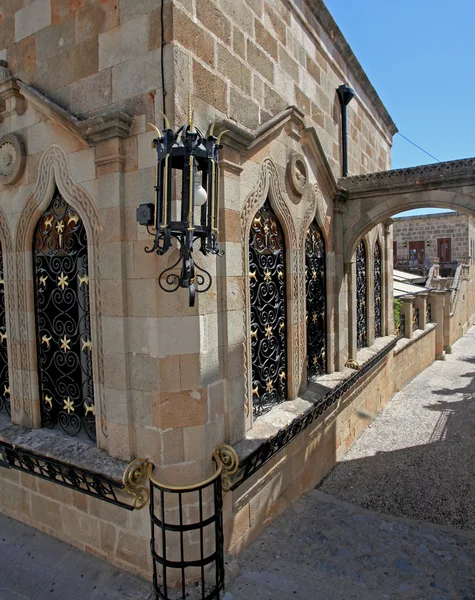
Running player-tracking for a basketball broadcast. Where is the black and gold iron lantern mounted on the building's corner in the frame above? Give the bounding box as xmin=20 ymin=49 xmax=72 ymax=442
xmin=137 ymin=101 xmax=225 ymax=306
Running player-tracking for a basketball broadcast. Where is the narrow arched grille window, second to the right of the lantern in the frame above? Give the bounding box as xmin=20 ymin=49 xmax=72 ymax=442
xmin=305 ymin=221 xmax=327 ymax=380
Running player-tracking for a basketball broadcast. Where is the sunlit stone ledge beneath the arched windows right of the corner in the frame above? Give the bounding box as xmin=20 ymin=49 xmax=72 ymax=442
xmin=234 ymin=336 xmax=398 ymax=463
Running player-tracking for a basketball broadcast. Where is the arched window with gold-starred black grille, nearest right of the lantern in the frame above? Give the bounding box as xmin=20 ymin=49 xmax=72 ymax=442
xmin=249 ymin=200 xmax=287 ymax=417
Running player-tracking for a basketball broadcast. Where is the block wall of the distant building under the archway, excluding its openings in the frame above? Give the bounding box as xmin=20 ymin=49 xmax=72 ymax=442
xmin=393 ymin=213 xmax=473 ymax=261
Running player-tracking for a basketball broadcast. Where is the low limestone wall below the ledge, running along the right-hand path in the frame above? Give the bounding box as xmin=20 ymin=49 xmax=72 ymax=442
xmin=224 ymin=325 xmax=435 ymax=554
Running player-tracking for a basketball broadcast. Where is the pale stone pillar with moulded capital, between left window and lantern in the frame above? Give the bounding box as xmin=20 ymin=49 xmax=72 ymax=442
xmin=80 ymin=111 xmax=135 ymax=460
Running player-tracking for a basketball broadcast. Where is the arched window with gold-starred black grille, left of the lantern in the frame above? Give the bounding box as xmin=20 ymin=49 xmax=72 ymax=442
xmin=33 ymin=190 xmax=96 ymax=439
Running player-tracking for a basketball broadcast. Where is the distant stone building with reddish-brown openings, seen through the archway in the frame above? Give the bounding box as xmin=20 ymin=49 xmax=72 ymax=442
xmin=393 ymin=212 xmax=475 ymax=264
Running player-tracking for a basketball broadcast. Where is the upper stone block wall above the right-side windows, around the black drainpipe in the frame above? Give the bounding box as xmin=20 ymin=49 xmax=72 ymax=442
xmin=172 ymin=0 xmax=391 ymax=177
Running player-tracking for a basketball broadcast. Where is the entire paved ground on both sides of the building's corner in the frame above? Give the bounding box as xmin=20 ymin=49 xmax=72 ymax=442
xmin=0 ymin=329 xmax=475 ymax=600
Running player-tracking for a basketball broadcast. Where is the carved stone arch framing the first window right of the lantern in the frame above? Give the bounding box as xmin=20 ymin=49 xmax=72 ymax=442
xmin=241 ymin=158 xmax=302 ymax=416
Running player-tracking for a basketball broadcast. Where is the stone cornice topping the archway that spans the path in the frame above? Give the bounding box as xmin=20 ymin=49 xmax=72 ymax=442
xmin=338 ymin=158 xmax=475 ymax=198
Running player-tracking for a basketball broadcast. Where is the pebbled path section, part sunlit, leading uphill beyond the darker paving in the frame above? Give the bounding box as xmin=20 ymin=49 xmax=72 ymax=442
xmin=319 ymin=327 xmax=475 ymax=529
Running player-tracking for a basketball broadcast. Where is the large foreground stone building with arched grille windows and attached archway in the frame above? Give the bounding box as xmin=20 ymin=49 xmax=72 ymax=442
xmin=0 ymin=0 xmax=474 ymax=598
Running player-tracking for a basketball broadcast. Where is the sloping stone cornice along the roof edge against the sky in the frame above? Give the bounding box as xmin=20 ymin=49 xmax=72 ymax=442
xmin=303 ymin=0 xmax=398 ymax=135
